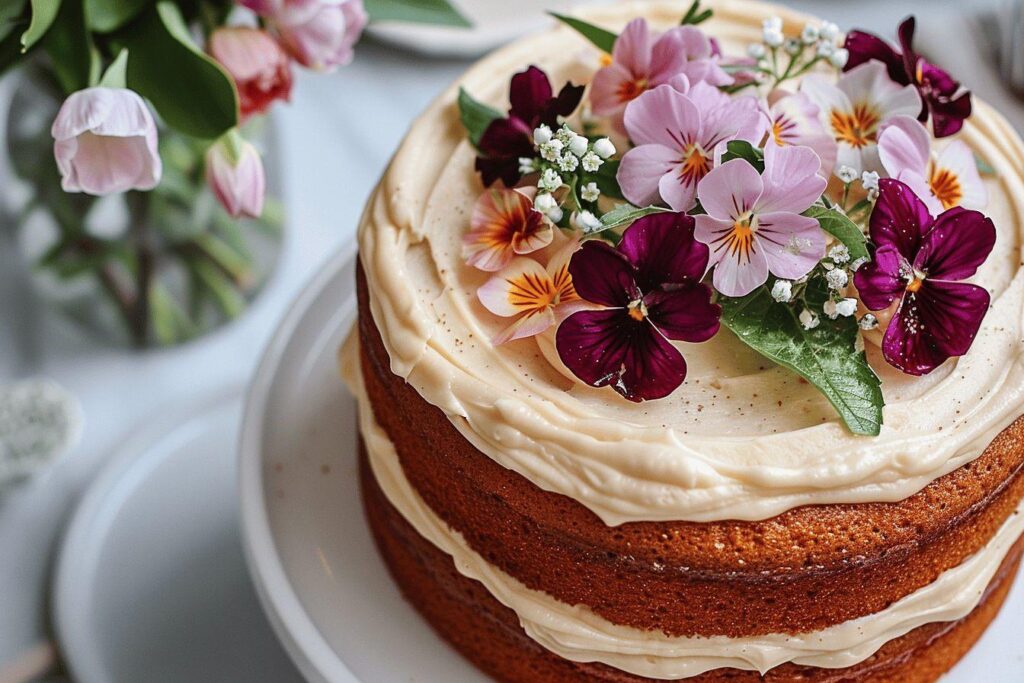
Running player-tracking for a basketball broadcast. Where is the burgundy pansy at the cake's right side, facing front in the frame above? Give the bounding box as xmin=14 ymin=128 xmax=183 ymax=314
xmin=853 ymin=178 xmax=995 ymax=375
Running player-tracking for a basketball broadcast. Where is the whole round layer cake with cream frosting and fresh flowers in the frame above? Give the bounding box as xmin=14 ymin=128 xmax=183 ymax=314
xmin=342 ymin=0 xmax=1024 ymax=683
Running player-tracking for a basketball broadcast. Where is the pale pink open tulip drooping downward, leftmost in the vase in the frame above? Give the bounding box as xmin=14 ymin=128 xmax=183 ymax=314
xmin=50 ymin=87 xmax=163 ymax=195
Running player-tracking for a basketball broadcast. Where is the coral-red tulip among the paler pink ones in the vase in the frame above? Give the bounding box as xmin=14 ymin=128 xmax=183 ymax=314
xmin=209 ymin=27 xmax=292 ymax=119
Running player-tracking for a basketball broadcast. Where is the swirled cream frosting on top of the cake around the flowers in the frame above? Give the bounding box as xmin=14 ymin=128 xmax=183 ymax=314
xmin=359 ymin=0 xmax=1024 ymax=525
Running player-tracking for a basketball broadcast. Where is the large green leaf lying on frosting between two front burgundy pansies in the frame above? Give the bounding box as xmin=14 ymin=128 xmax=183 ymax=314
xmin=718 ymin=276 xmax=885 ymax=436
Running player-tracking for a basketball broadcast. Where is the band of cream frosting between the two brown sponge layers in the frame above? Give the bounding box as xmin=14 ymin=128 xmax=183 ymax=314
xmin=344 ymin=338 xmax=1024 ymax=679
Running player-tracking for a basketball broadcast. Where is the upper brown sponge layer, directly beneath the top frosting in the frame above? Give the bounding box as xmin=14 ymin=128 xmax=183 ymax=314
xmin=358 ymin=267 xmax=1024 ymax=637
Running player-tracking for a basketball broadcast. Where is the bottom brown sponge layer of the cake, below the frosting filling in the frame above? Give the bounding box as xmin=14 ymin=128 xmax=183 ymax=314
xmin=359 ymin=443 xmax=1024 ymax=683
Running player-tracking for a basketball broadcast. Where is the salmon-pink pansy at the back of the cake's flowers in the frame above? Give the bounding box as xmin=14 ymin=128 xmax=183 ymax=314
xmin=590 ymin=18 xmax=732 ymax=131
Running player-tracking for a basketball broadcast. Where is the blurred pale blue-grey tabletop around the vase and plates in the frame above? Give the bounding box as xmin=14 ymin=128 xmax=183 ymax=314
xmin=0 ymin=0 xmax=1024 ymax=669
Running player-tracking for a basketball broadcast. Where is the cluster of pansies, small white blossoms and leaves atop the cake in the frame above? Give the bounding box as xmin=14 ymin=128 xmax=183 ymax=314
xmin=459 ymin=2 xmax=995 ymax=435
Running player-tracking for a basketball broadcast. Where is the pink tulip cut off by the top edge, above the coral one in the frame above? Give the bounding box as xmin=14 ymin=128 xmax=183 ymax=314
xmin=242 ymin=0 xmax=368 ymax=71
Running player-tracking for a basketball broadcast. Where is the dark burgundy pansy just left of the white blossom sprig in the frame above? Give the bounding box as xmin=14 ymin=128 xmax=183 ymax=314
xmin=476 ymin=67 xmax=584 ymax=187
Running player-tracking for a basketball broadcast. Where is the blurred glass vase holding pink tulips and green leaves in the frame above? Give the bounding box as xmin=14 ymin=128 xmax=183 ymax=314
xmin=0 ymin=0 xmax=465 ymax=346
